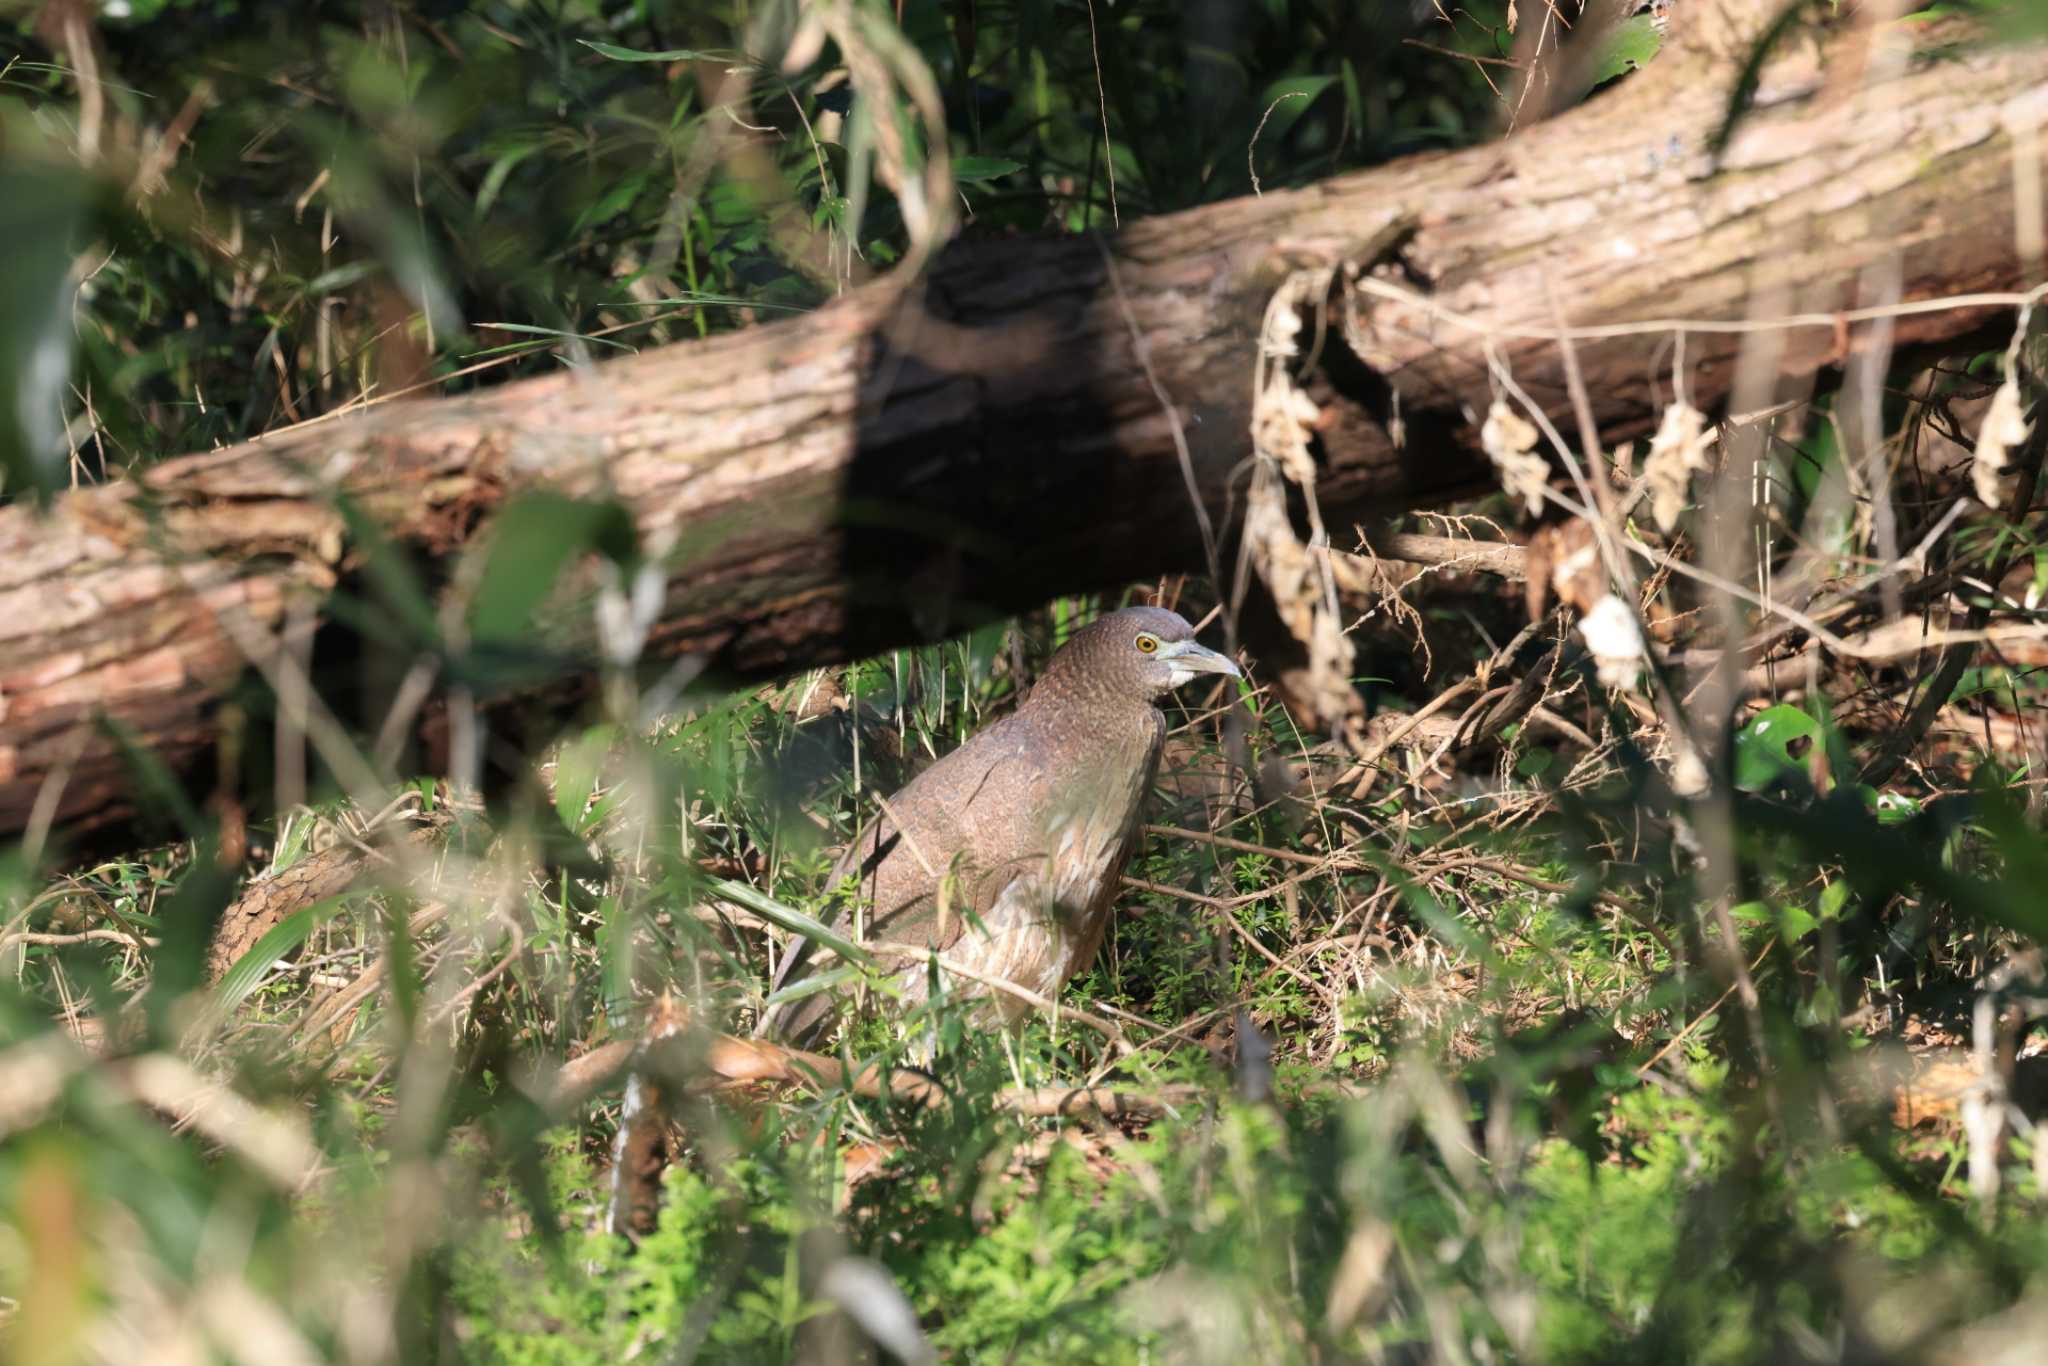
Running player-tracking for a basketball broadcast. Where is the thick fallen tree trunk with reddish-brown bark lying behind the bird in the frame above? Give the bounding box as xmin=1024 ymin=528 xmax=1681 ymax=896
xmin=0 ymin=18 xmax=2048 ymax=829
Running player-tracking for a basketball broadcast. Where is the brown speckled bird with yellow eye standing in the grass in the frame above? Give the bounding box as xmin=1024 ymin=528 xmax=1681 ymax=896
xmin=756 ymin=606 xmax=1243 ymax=1042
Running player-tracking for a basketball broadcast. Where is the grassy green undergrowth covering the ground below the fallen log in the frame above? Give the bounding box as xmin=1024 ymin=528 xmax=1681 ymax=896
xmin=12 ymin=602 xmax=2048 ymax=1362
